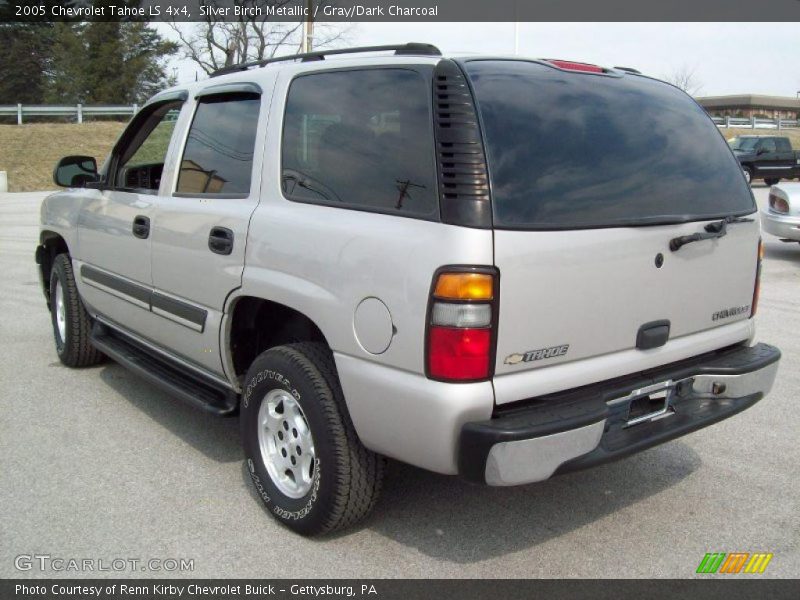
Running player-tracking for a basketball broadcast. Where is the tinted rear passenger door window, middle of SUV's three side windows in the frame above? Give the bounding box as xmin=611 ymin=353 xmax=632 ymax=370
xmin=176 ymin=96 xmax=261 ymax=195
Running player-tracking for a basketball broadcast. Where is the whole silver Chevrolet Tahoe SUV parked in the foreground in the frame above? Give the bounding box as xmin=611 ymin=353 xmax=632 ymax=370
xmin=37 ymin=44 xmax=780 ymax=534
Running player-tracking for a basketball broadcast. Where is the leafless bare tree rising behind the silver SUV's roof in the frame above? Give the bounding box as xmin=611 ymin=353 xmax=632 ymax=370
xmin=170 ymin=0 xmax=352 ymax=74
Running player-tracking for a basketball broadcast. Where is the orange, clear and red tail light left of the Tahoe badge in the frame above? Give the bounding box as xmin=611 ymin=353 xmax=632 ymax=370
xmin=426 ymin=267 xmax=498 ymax=382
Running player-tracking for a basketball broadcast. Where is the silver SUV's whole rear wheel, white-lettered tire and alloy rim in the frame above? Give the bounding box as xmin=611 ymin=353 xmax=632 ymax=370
xmin=240 ymin=342 xmax=384 ymax=535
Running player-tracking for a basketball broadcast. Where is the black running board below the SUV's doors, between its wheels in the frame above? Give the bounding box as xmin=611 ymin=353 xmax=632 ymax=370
xmin=91 ymin=322 xmax=238 ymax=416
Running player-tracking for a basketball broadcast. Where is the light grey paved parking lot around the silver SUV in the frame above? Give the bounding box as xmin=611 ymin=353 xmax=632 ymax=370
xmin=0 ymin=185 xmax=800 ymax=578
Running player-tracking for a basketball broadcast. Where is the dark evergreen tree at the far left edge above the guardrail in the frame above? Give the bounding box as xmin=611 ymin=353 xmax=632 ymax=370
xmin=0 ymin=23 xmax=53 ymax=104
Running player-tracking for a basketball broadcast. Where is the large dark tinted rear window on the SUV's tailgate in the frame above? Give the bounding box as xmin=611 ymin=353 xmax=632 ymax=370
xmin=466 ymin=60 xmax=755 ymax=229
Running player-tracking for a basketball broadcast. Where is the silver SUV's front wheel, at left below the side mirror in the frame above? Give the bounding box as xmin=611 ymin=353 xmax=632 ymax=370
xmin=50 ymin=254 xmax=104 ymax=367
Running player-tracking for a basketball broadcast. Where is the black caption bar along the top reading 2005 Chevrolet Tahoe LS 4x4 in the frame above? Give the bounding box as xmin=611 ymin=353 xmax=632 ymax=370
xmin=0 ymin=0 xmax=800 ymax=22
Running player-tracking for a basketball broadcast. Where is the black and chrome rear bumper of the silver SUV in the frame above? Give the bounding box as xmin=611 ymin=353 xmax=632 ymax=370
xmin=458 ymin=344 xmax=780 ymax=486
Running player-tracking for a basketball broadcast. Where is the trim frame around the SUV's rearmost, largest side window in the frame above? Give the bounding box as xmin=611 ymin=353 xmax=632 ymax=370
xmin=277 ymin=64 xmax=441 ymax=223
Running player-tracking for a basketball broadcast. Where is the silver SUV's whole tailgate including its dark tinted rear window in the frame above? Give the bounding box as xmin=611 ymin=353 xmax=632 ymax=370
xmin=463 ymin=59 xmax=759 ymax=404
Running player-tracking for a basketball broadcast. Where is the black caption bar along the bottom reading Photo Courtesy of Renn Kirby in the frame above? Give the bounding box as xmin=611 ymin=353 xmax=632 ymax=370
xmin=0 ymin=580 xmax=800 ymax=600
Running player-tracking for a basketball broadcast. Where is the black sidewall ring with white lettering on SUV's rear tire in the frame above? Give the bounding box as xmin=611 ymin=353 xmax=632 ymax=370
xmin=241 ymin=350 xmax=337 ymax=533
